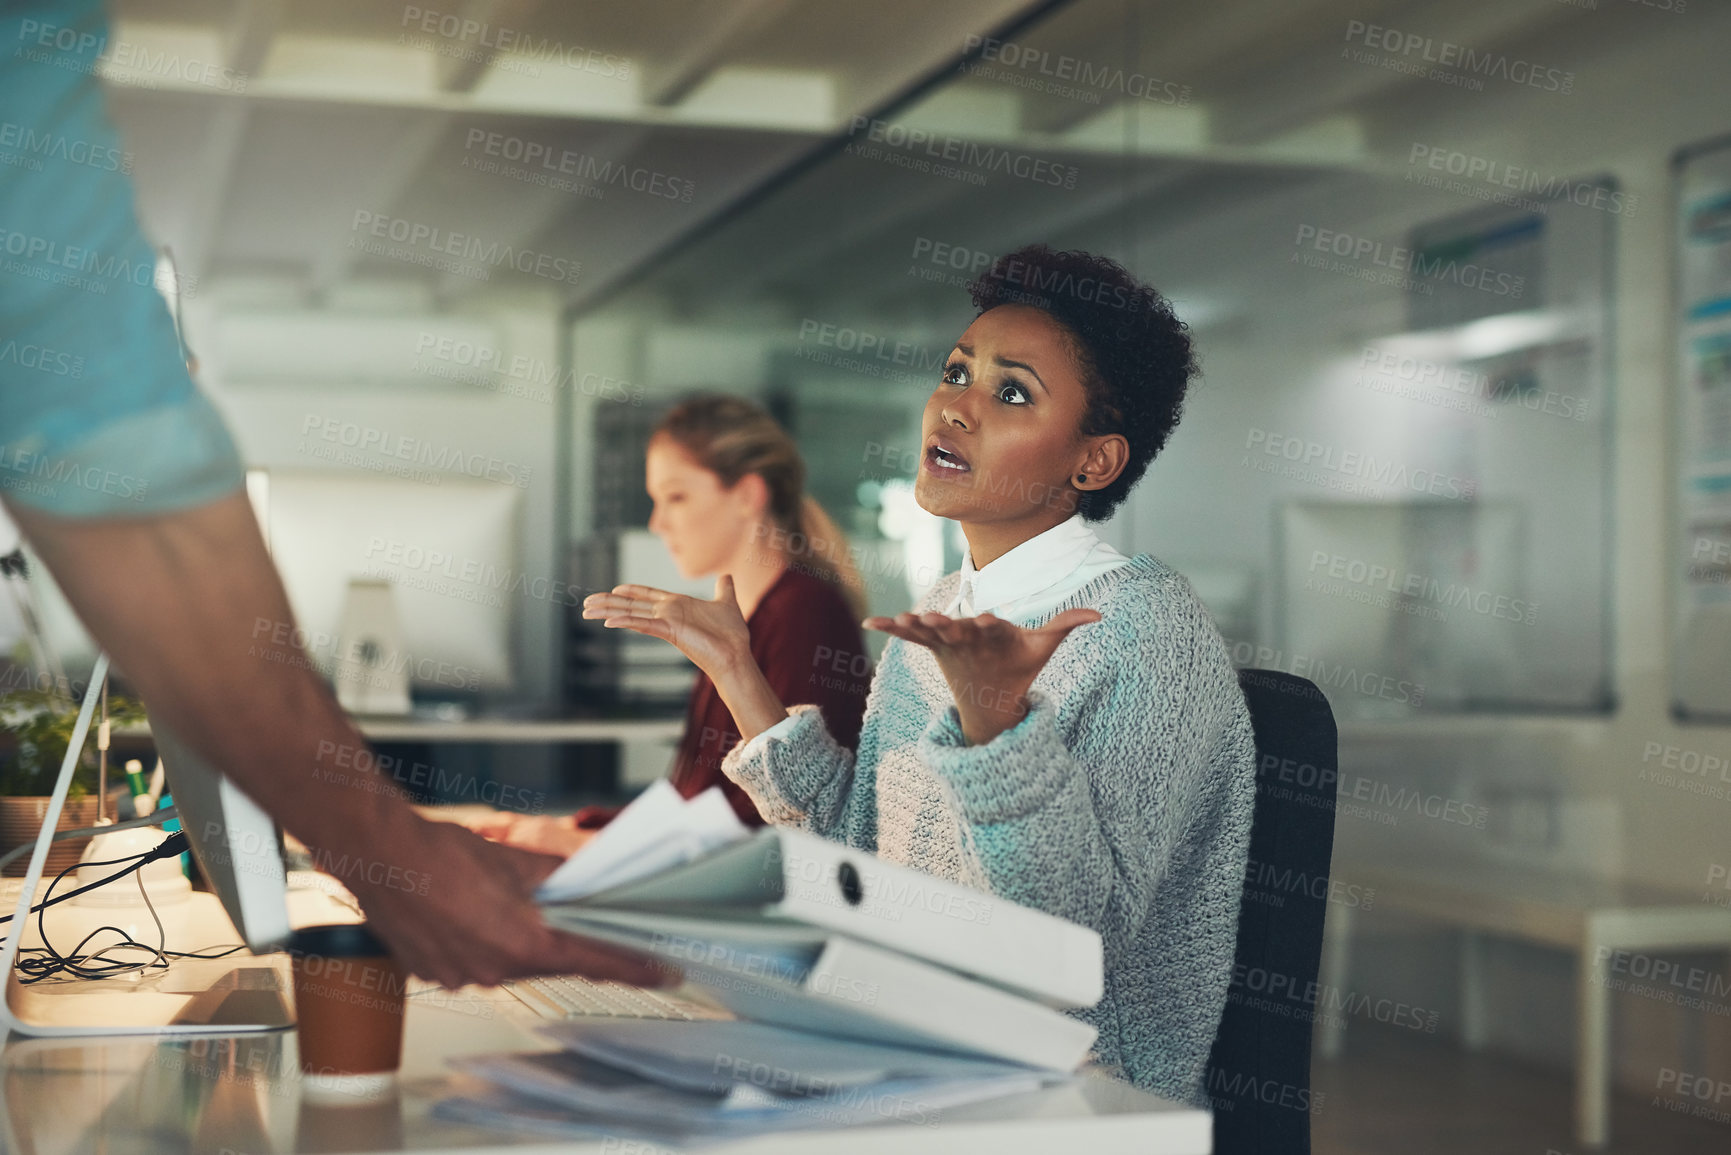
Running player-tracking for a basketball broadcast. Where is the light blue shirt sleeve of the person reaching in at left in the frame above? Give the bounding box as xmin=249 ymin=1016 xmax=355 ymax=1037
xmin=0 ymin=0 xmax=244 ymax=518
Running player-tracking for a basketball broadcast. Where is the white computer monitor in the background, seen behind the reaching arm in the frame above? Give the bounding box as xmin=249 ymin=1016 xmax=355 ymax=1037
xmin=248 ymin=469 xmax=524 ymax=705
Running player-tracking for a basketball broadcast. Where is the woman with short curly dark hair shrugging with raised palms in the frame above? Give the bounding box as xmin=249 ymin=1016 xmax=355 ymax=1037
xmin=585 ymin=246 xmax=1255 ymax=1105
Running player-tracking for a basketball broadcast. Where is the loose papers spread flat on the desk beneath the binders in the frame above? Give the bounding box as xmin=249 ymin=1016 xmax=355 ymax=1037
xmin=434 ymin=1018 xmax=1059 ymax=1141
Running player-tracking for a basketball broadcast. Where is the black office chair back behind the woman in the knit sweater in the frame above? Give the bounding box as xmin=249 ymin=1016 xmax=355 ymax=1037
xmin=1208 ymin=670 xmax=1340 ymax=1155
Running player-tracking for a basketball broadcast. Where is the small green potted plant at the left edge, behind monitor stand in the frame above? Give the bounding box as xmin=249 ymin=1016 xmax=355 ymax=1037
xmin=0 ymin=689 xmax=144 ymax=876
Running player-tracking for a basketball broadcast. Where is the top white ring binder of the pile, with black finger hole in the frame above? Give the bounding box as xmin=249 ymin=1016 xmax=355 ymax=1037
xmin=549 ymin=828 xmax=1104 ymax=1008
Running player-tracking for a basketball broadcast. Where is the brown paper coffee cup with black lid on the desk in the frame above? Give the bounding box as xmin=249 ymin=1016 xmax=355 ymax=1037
xmin=289 ymin=923 xmax=409 ymax=1093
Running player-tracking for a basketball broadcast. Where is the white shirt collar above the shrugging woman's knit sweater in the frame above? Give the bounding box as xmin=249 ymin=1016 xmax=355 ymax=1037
xmin=943 ymin=514 xmax=1129 ymax=625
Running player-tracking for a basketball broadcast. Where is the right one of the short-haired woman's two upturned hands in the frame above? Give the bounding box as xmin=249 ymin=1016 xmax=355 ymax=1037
xmin=864 ymin=610 xmax=1099 ymax=746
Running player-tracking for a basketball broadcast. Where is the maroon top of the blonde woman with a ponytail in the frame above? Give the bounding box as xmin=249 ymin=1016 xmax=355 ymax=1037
xmin=576 ymin=566 xmax=871 ymax=828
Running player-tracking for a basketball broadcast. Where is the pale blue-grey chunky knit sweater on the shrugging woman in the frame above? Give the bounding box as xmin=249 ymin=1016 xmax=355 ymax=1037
xmin=722 ymin=554 xmax=1255 ymax=1107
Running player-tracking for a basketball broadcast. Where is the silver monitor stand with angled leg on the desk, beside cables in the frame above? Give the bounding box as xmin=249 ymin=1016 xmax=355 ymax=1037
xmin=0 ymin=653 xmax=294 ymax=1037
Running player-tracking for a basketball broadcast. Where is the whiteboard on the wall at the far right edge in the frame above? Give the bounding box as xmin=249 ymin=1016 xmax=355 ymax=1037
xmin=1672 ymin=137 xmax=1731 ymax=722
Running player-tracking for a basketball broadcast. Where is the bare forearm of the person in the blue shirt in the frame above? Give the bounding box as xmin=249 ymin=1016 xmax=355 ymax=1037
xmin=10 ymin=494 xmax=415 ymax=850
